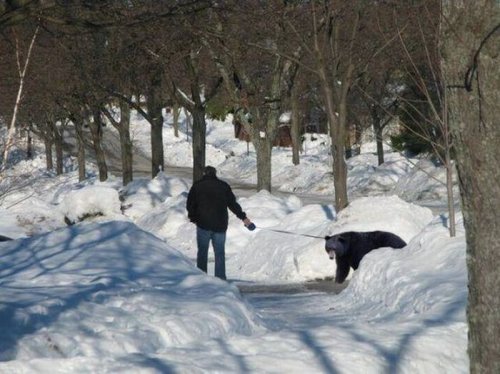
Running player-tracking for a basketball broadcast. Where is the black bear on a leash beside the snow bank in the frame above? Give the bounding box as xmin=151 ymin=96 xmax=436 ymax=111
xmin=325 ymin=231 xmax=406 ymax=283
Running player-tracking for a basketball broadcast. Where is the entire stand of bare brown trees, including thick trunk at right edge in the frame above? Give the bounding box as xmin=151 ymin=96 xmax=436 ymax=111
xmin=0 ymin=0 xmax=500 ymax=373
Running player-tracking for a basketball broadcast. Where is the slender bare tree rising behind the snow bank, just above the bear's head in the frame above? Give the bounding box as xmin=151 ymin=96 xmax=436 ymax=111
xmin=281 ymin=0 xmax=372 ymax=211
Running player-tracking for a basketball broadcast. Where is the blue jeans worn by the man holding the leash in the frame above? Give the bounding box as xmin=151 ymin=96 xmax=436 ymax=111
xmin=196 ymin=227 xmax=226 ymax=279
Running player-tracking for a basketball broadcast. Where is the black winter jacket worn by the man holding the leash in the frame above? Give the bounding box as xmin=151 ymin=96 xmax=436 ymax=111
xmin=186 ymin=175 xmax=246 ymax=232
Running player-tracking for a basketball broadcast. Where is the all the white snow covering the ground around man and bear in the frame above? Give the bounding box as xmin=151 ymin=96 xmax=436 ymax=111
xmin=0 ymin=109 xmax=468 ymax=374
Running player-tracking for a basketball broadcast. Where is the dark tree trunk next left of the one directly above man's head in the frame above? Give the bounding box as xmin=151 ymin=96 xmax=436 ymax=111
xmin=146 ymin=73 xmax=165 ymax=178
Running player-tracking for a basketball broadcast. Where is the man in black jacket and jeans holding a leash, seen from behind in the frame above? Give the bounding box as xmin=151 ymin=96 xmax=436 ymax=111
xmin=186 ymin=166 xmax=255 ymax=279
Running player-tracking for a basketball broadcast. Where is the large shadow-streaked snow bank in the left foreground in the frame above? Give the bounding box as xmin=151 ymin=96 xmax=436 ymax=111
xmin=0 ymin=222 xmax=259 ymax=361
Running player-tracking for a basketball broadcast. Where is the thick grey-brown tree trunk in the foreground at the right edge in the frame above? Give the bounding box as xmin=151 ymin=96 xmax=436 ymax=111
xmin=442 ymin=0 xmax=500 ymax=374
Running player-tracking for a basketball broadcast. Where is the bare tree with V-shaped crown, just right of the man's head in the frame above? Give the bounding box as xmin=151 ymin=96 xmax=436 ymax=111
xmin=203 ymin=1 xmax=298 ymax=191
